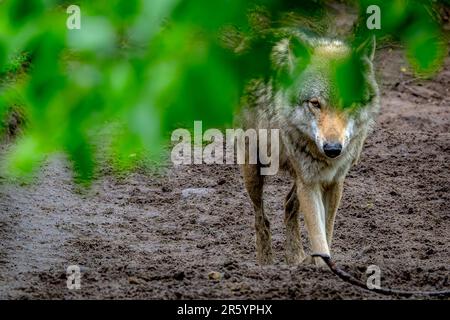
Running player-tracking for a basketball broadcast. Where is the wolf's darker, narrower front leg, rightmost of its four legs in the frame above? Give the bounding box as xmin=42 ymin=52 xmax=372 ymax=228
xmin=323 ymin=181 xmax=344 ymax=250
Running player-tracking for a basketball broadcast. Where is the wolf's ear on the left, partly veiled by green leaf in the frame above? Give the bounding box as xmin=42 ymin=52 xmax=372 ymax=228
xmin=270 ymin=36 xmax=311 ymax=74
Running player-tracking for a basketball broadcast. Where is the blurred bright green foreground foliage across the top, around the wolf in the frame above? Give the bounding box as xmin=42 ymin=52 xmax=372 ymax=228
xmin=0 ymin=0 xmax=446 ymax=181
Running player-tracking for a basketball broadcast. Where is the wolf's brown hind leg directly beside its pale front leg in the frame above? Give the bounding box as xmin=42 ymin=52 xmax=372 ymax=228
xmin=284 ymin=183 xmax=305 ymax=265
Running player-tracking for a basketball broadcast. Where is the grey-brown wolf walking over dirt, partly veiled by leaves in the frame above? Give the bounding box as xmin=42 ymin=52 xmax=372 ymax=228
xmin=238 ymin=31 xmax=380 ymax=265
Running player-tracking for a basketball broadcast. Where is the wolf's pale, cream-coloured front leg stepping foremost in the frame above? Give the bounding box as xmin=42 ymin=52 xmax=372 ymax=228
xmin=297 ymin=181 xmax=330 ymax=265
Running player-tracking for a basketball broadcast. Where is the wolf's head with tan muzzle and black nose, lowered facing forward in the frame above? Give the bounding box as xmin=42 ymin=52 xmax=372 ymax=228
xmin=272 ymin=33 xmax=379 ymax=158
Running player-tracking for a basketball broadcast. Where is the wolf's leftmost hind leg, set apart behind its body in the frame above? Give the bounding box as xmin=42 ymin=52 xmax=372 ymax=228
xmin=242 ymin=164 xmax=273 ymax=265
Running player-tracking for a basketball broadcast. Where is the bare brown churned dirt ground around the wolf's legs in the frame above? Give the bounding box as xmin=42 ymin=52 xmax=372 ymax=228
xmin=0 ymin=37 xmax=450 ymax=299
